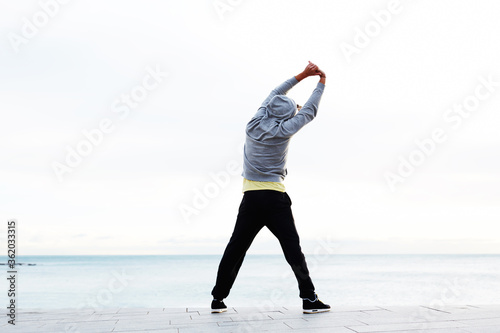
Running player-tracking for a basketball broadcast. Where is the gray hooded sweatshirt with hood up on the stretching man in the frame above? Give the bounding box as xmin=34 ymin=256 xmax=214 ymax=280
xmin=242 ymin=77 xmax=325 ymax=182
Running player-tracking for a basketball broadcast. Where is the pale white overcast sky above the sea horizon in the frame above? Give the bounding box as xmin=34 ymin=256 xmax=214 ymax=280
xmin=0 ymin=0 xmax=500 ymax=254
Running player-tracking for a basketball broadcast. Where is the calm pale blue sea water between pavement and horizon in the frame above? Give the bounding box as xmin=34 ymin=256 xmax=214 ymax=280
xmin=0 ymin=254 xmax=500 ymax=309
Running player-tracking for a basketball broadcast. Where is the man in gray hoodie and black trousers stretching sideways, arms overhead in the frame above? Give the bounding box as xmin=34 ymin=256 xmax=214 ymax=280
xmin=211 ymin=62 xmax=330 ymax=313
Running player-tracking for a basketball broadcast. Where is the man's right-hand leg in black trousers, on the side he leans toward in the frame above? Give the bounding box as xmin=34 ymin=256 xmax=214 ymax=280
xmin=266 ymin=189 xmax=315 ymax=299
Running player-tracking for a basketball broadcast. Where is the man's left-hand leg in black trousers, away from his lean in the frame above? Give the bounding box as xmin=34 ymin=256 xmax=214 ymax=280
xmin=212 ymin=191 xmax=264 ymax=300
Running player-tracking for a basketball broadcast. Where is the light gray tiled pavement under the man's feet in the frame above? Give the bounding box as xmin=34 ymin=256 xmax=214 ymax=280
xmin=0 ymin=305 xmax=500 ymax=333
